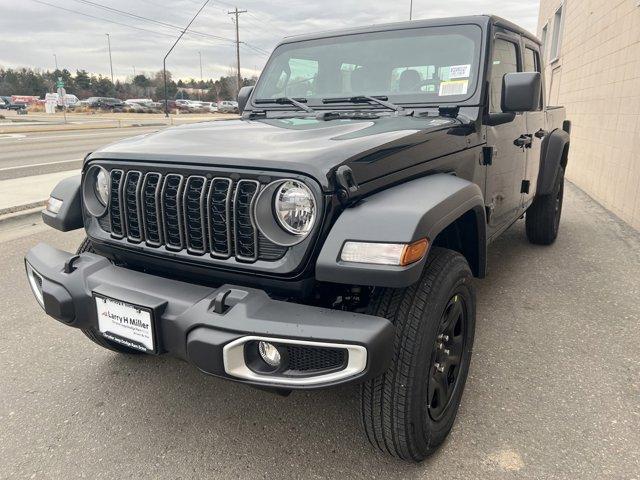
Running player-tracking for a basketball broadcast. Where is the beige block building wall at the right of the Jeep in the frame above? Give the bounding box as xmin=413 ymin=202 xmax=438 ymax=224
xmin=538 ymin=0 xmax=640 ymax=230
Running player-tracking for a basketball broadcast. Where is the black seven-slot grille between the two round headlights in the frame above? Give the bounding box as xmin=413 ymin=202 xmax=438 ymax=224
xmin=108 ymin=169 xmax=286 ymax=262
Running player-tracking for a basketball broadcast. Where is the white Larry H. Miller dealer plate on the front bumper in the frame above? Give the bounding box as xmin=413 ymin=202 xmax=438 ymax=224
xmin=94 ymin=294 xmax=156 ymax=353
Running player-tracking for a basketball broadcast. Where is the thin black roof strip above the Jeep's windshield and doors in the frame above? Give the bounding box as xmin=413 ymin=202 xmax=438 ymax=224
xmin=280 ymin=15 xmax=541 ymax=43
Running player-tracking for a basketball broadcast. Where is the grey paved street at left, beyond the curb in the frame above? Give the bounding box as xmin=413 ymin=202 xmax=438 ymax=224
xmin=0 ymin=126 xmax=164 ymax=180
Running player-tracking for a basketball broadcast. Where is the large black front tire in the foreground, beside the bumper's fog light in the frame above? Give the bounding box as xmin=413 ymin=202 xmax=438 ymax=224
xmin=361 ymin=247 xmax=476 ymax=462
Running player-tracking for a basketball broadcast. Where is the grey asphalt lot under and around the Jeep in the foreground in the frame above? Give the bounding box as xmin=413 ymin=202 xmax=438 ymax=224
xmin=0 ymin=182 xmax=640 ymax=480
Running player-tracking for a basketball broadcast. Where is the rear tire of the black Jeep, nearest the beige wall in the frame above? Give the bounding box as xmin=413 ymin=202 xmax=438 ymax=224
xmin=525 ymin=167 xmax=564 ymax=245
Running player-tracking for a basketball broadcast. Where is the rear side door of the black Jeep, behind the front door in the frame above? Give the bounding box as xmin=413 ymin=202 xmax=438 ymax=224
xmin=522 ymin=39 xmax=546 ymax=209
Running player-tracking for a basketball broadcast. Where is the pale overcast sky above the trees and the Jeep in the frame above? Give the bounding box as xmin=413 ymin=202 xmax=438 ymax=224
xmin=0 ymin=0 xmax=539 ymax=79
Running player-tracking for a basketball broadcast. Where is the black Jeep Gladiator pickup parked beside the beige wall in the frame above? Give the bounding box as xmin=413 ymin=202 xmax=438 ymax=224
xmin=25 ymin=16 xmax=570 ymax=461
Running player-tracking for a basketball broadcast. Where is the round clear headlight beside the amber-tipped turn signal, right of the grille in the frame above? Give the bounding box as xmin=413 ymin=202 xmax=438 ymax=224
xmin=274 ymin=180 xmax=316 ymax=235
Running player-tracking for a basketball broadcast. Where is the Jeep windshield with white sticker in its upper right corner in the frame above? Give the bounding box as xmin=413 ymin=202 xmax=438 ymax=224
xmin=253 ymin=25 xmax=481 ymax=104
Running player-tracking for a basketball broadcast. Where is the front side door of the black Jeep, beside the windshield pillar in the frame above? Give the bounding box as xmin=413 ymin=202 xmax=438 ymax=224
xmin=485 ymin=29 xmax=527 ymax=236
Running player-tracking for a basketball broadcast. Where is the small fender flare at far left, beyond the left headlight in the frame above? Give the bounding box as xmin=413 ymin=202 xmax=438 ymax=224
xmin=42 ymin=175 xmax=84 ymax=232
